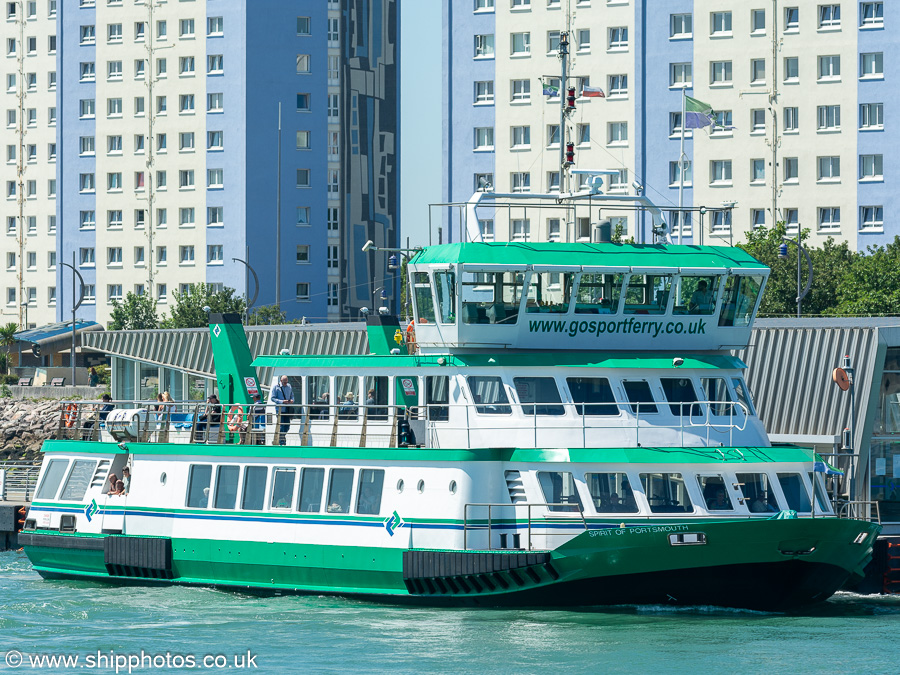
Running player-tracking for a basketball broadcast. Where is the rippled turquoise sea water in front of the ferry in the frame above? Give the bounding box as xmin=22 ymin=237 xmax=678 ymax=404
xmin=0 ymin=551 xmax=900 ymax=675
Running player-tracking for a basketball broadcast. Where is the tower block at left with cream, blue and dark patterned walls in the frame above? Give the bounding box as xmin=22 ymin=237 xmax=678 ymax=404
xmin=3 ymin=0 xmax=399 ymax=324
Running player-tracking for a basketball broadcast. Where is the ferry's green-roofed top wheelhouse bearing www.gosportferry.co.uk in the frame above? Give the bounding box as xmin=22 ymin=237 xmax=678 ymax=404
xmin=408 ymin=242 xmax=769 ymax=353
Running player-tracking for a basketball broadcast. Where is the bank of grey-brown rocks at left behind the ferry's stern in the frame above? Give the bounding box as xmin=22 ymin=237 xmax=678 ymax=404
xmin=0 ymin=399 xmax=59 ymax=460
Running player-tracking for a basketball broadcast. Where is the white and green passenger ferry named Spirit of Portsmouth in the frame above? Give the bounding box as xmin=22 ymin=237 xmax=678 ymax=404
xmin=20 ymin=236 xmax=879 ymax=609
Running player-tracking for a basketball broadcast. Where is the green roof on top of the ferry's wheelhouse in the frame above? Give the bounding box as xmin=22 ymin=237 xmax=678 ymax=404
xmin=410 ymin=242 xmax=768 ymax=272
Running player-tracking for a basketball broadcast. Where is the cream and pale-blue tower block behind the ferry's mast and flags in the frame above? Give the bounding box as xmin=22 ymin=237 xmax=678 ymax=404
xmin=444 ymin=0 xmax=900 ymax=249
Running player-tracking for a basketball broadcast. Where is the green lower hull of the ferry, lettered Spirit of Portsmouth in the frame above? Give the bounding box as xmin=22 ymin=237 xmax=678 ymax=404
xmin=23 ymin=518 xmax=879 ymax=609
